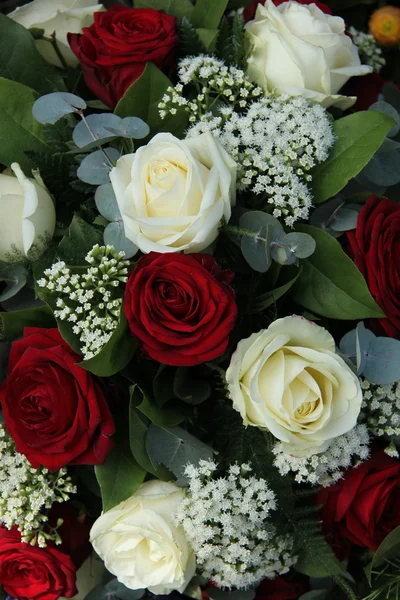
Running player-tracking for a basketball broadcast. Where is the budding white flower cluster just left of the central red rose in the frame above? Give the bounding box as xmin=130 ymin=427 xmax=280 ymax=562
xmin=38 ymin=244 xmax=129 ymax=359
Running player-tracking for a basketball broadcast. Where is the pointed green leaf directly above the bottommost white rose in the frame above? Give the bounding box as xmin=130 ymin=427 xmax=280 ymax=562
xmin=95 ymin=440 xmax=146 ymax=511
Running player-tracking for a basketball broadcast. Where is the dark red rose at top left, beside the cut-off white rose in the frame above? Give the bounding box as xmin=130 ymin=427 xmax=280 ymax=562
xmin=68 ymin=4 xmax=179 ymax=107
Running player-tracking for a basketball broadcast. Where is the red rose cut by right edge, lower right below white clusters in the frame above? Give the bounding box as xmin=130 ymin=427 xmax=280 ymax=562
xmin=316 ymin=452 xmax=400 ymax=551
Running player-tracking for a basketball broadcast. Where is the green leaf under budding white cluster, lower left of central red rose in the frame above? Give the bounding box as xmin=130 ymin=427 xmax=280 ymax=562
xmin=79 ymin=307 xmax=137 ymax=377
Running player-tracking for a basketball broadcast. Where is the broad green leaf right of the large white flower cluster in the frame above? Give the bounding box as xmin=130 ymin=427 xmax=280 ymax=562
xmin=312 ymin=111 xmax=395 ymax=204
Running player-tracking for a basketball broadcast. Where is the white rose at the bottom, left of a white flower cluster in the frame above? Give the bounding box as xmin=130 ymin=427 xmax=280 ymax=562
xmin=90 ymin=480 xmax=196 ymax=594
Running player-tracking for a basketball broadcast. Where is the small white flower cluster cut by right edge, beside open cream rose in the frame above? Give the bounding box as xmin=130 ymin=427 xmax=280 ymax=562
xmin=360 ymin=377 xmax=400 ymax=458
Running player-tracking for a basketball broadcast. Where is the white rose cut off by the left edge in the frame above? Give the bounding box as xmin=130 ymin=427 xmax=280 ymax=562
xmin=0 ymin=163 xmax=56 ymax=261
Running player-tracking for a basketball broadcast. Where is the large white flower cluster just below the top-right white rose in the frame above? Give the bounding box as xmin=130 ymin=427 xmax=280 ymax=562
xmin=187 ymin=94 xmax=335 ymax=227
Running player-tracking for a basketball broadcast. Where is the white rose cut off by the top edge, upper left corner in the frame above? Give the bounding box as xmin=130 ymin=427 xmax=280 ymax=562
xmin=8 ymin=0 xmax=105 ymax=67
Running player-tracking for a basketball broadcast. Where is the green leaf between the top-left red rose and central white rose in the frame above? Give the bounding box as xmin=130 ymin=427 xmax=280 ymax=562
xmin=115 ymin=63 xmax=187 ymax=135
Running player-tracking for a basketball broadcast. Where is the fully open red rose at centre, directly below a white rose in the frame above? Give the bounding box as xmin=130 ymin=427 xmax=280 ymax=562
xmin=124 ymin=252 xmax=237 ymax=367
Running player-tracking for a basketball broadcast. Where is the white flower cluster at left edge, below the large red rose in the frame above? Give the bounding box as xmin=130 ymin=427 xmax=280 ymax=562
xmin=0 ymin=425 xmax=76 ymax=548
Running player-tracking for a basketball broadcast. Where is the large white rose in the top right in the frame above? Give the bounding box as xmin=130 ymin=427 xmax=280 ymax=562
xmin=246 ymin=0 xmax=372 ymax=109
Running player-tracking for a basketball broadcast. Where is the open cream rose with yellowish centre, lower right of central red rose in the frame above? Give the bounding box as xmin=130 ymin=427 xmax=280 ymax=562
xmin=226 ymin=316 xmax=362 ymax=456
